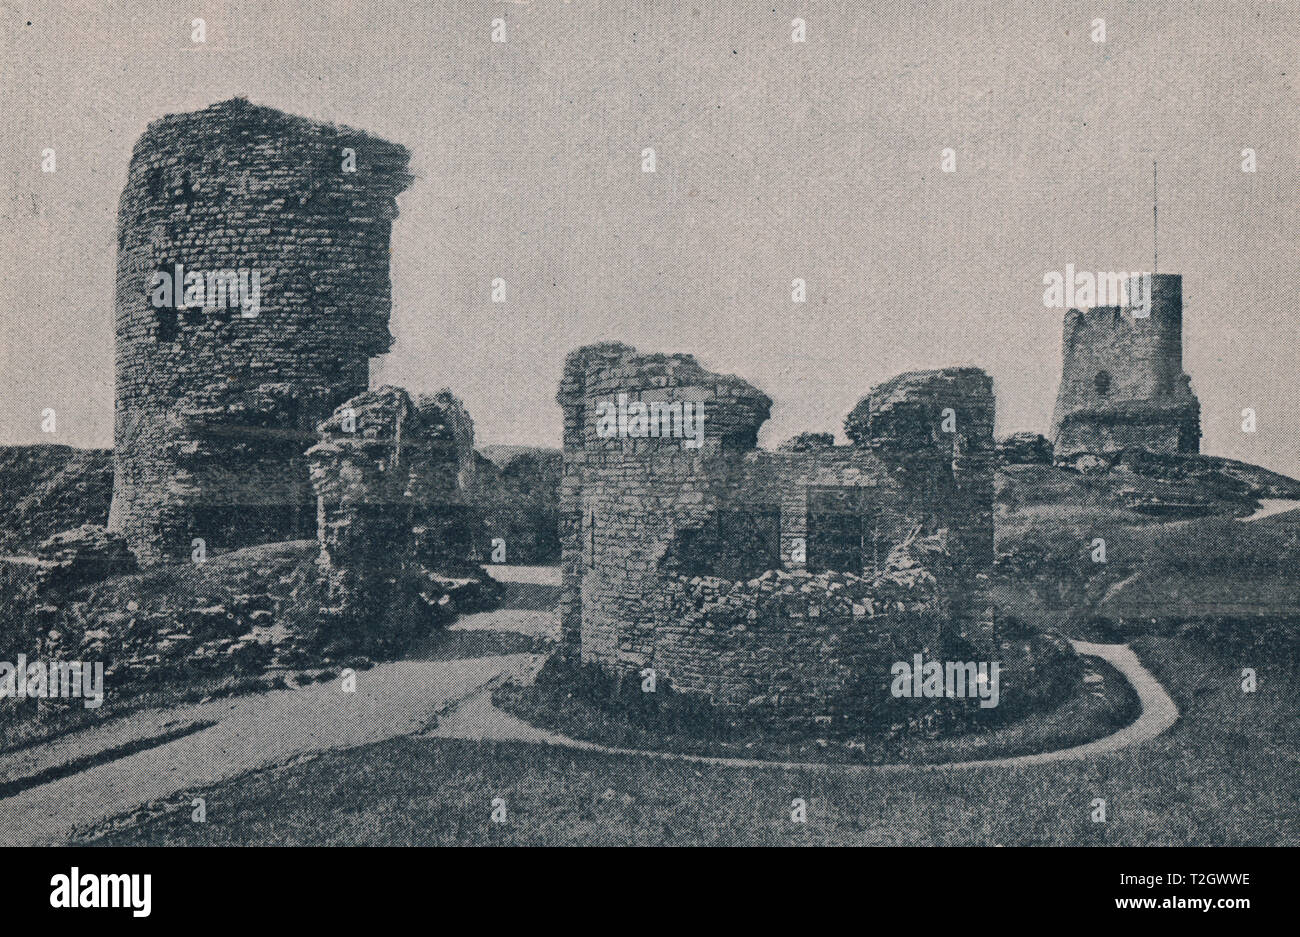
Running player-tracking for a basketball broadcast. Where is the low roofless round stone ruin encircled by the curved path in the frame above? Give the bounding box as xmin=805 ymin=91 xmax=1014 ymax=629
xmin=558 ymin=343 xmax=995 ymax=712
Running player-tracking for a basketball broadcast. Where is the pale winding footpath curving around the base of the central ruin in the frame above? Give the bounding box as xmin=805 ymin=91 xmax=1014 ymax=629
xmin=0 ymin=564 xmax=1178 ymax=845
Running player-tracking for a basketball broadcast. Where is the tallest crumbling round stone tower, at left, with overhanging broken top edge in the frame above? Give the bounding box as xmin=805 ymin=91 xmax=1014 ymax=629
xmin=109 ymin=97 xmax=412 ymax=564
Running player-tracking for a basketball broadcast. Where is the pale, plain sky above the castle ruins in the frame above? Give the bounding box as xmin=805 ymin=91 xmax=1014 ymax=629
xmin=0 ymin=0 xmax=1300 ymax=474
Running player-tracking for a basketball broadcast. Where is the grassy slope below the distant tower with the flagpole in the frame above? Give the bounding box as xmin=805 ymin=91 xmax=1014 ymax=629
xmin=992 ymin=460 xmax=1300 ymax=652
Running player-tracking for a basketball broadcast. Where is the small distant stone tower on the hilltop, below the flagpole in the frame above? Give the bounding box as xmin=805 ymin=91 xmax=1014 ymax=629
xmin=1052 ymin=273 xmax=1201 ymax=460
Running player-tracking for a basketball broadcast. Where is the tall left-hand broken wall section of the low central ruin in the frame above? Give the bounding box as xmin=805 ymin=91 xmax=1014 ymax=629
xmin=558 ymin=343 xmax=772 ymax=668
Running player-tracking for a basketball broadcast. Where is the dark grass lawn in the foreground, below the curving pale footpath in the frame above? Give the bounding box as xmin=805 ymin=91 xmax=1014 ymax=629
xmin=83 ymin=637 xmax=1300 ymax=846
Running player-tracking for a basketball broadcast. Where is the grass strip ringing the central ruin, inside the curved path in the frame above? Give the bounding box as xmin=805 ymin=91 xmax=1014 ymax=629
xmin=493 ymin=623 xmax=1138 ymax=764
